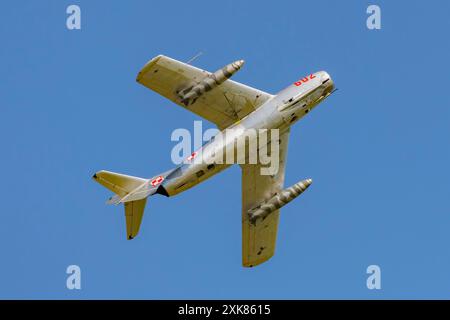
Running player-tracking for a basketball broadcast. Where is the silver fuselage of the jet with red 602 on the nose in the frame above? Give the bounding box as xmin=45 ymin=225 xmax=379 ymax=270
xmin=159 ymin=71 xmax=334 ymax=196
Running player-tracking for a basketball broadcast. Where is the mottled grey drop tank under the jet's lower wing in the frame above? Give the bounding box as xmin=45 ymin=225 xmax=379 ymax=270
xmin=248 ymin=179 xmax=312 ymax=224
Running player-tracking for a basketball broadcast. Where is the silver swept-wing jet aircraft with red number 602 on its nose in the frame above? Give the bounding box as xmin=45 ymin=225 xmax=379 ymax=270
xmin=93 ymin=55 xmax=334 ymax=267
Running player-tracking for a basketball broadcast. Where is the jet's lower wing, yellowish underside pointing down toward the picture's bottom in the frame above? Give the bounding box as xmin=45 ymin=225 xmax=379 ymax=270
xmin=241 ymin=131 xmax=289 ymax=267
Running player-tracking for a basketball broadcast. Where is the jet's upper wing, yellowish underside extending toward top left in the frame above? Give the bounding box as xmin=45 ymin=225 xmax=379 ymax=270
xmin=136 ymin=55 xmax=272 ymax=129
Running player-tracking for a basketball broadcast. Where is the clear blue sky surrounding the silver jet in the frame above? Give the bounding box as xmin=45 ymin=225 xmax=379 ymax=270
xmin=0 ymin=1 xmax=450 ymax=299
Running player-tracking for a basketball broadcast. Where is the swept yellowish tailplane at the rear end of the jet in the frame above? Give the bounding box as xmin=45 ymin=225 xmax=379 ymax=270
xmin=92 ymin=170 xmax=155 ymax=240
